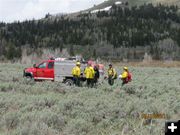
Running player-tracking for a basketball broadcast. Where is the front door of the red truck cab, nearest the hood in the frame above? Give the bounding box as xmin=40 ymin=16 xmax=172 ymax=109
xmin=35 ymin=62 xmax=47 ymax=80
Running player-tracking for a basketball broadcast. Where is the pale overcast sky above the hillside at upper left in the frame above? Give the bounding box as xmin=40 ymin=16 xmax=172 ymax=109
xmin=0 ymin=0 xmax=104 ymax=22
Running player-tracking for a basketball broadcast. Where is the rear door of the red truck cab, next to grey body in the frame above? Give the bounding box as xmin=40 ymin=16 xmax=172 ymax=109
xmin=44 ymin=61 xmax=54 ymax=80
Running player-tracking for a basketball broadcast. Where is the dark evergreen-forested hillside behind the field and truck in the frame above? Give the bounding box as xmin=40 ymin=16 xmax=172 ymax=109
xmin=0 ymin=3 xmax=180 ymax=59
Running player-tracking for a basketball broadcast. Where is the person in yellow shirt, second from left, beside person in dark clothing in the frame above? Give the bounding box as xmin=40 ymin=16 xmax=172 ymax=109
xmin=84 ymin=63 xmax=95 ymax=88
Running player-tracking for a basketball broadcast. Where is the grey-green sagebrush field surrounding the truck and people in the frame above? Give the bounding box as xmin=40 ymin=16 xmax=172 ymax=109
xmin=0 ymin=63 xmax=180 ymax=135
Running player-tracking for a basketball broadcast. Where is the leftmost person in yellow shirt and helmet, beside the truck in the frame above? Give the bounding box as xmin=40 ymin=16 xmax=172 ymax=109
xmin=72 ymin=62 xmax=81 ymax=86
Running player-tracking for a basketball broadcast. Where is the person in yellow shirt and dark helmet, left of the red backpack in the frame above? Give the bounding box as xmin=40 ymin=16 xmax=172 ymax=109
xmin=108 ymin=64 xmax=117 ymax=85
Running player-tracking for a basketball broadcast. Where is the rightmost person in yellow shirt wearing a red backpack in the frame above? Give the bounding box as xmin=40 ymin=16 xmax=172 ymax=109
xmin=119 ymin=67 xmax=132 ymax=86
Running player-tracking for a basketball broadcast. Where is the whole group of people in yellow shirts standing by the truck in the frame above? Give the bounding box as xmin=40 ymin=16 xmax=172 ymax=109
xmin=72 ymin=62 xmax=131 ymax=88
